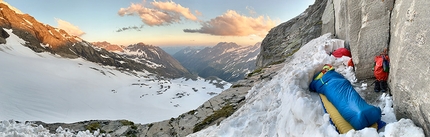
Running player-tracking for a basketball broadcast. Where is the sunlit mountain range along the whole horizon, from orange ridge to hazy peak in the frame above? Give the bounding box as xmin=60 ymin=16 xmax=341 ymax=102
xmin=0 ymin=3 xmax=260 ymax=82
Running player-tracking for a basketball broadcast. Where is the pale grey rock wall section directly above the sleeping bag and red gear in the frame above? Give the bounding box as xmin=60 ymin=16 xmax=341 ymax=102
xmin=322 ymin=0 xmax=394 ymax=79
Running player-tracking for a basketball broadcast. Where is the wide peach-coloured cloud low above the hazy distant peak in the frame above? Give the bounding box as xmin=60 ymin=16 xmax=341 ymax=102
xmin=184 ymin=10 xmax=279 ymax=37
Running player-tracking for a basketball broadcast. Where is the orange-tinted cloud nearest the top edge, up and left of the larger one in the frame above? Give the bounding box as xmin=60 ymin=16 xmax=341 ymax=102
xmin=118 ymin=1 xmax=197 ymax=26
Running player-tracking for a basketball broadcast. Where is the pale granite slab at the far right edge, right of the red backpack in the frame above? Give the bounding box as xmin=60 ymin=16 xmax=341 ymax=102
xmin=389 ymin=0 xmax=430 ymax=136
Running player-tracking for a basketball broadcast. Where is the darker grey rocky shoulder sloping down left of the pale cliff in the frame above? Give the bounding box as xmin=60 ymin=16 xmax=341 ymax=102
xmin=257 ymin=0 xmax=327 ymax=68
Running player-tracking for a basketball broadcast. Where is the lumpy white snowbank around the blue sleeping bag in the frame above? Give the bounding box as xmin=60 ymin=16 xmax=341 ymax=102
xmin=189 ymin=34 xmax=424 ymax=137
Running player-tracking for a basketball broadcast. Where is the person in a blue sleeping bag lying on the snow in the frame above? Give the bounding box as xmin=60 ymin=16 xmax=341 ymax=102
xmin=309 ymin=64 xmax=381 ymax=130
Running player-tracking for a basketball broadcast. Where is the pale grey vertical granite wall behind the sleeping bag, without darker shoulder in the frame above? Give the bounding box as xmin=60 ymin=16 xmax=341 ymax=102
xmin=322 ymin=0 xmax=430 ymax=136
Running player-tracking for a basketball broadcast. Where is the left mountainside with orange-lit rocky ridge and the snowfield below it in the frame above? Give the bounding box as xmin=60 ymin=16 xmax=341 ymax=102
xmin=0 ymin=1 xmax=231 ymax=126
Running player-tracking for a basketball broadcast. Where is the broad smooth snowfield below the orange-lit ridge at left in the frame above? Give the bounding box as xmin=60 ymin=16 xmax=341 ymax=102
xmin=0 ymin=30 xmax=230 ymax=124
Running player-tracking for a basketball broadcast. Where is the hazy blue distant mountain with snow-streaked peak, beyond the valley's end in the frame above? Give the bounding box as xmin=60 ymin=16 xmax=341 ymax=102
xmin=173 ymin=42 xmax=261 ymax=82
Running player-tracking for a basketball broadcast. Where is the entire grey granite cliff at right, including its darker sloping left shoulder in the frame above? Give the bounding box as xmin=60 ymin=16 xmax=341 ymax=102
xmin=257 ymin=0 xmax=430 ymax=136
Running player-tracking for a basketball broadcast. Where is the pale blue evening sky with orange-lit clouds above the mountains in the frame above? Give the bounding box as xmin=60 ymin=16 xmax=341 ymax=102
xmin=3 ymin=0 xmax=315 ymax=46
